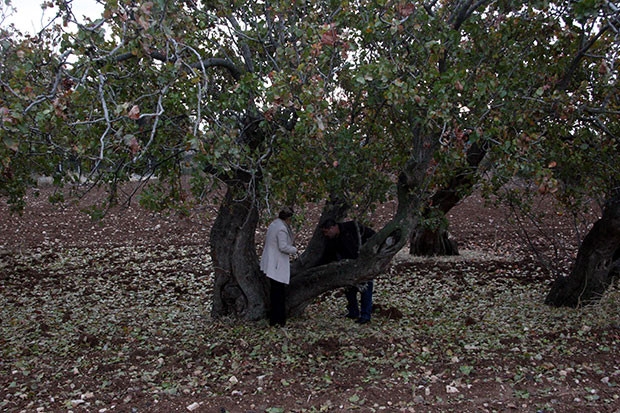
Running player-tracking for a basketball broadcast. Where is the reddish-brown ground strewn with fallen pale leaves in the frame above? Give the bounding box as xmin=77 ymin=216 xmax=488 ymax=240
xmin=0 ymin=185 xmax=620 ymax=413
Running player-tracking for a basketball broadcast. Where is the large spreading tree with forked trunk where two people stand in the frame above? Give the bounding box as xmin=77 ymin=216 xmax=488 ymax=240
xmin=0 ymin=0 xmax=617 ymax=320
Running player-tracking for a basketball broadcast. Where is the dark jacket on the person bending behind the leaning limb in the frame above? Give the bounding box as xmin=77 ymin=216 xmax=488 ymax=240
xmin=321 ymin=221 xmax=375 ymax=264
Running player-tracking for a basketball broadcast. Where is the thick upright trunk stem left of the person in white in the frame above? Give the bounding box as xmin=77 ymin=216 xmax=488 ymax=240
xmin=210 ymin=173 xmax=269 ymax=320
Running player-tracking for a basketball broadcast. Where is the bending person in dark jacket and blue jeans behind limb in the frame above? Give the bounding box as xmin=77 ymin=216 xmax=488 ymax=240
xmin=321 ymin=219 xmax=375 ymax=324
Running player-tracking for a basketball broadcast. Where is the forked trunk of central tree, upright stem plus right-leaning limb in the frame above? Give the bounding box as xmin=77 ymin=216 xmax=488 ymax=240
xmin=210 ymin=129 xmax=432 ymax=320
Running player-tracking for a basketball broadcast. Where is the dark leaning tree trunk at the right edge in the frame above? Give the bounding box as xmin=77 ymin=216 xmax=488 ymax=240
xmin=545 ymin=193 xmax=620 ymax=307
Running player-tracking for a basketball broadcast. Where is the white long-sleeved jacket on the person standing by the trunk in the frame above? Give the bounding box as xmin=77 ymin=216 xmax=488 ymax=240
xmin=260 ymin=218 xmax=297 ymax=284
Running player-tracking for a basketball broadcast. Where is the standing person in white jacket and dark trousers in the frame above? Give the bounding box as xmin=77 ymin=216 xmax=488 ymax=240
xmin=260 ymin=208 xmax=297 ymax=327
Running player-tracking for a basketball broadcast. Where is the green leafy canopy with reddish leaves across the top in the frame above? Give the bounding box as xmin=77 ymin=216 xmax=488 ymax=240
xmin=2 ymin=1 xmax=618 ymax=209
